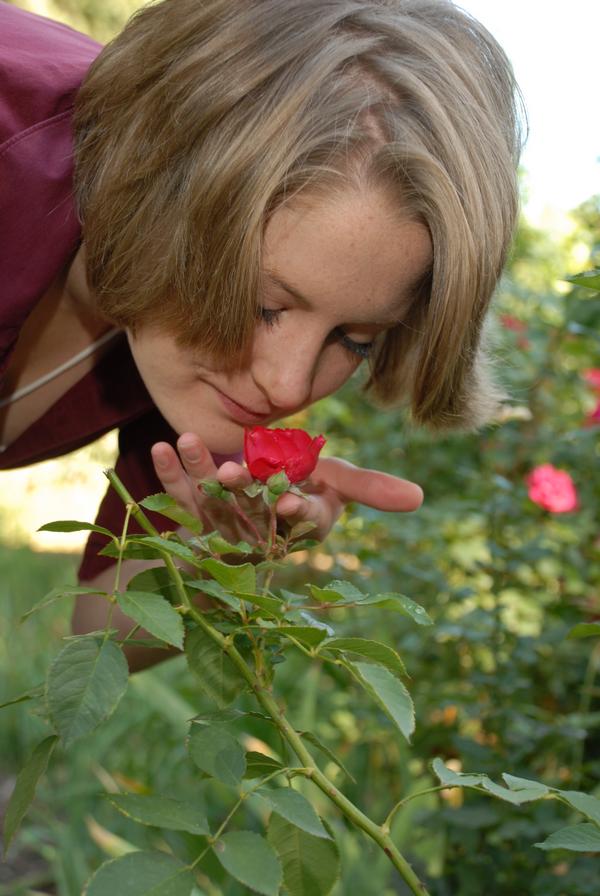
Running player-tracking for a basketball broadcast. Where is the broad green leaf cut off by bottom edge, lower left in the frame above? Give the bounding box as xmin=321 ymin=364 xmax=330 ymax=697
xmin=83 ymin=850 xmax=194 ymax=896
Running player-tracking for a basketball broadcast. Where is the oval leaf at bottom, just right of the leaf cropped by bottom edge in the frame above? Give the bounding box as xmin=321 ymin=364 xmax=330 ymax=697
xmin=213 ymin=831 xmax=283 ymax=896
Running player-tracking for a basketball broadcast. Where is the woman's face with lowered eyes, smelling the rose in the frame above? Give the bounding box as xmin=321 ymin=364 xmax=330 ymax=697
xmin=129 ymin=189 xmax=432 ymax=454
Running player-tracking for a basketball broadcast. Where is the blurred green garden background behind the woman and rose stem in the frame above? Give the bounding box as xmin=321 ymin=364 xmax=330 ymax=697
xmin=0 ymin=0 xmax=600 ymax=896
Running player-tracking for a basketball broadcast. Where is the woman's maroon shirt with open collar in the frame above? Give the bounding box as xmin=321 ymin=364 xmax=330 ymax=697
xmin=0 ymin=0 xmax=238 ymax=581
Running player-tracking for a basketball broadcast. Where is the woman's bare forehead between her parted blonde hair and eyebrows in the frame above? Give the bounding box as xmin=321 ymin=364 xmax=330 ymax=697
xmin=262 ymin=189 xmax=432 ymax=325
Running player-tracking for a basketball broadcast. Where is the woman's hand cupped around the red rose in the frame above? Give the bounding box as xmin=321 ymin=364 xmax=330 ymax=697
xmin=152 ymin=433 xmax=423 ymax=541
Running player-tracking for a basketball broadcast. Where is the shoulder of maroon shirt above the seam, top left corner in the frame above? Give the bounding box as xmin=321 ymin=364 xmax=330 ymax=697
xmin=0 ymin=0 xmax=101 ymax=147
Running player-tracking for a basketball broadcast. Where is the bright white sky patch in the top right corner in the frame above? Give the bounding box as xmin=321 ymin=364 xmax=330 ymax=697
xmin=457 ymin=0 xmax=600 ymax=220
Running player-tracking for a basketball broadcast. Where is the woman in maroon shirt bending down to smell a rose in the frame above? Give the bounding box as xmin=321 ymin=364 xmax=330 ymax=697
xmin=0 ymin=0 xmax=519 ymax=656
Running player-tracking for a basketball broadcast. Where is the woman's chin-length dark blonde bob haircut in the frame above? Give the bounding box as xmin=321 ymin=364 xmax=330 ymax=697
xmin=75 ymin=0 xmax=520 ymax=428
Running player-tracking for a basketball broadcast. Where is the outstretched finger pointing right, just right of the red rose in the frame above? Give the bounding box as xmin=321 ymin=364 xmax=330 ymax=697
xmin=311 ymin=457 xmax=423 ymax=512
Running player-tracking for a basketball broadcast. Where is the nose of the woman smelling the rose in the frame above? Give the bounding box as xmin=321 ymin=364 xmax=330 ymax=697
xmin=252 ymin=332 xmax=323 ymax=414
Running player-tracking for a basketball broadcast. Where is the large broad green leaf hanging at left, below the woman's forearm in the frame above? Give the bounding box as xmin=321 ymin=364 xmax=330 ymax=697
xmin=46 ymin=638 xmax=129 ymax=747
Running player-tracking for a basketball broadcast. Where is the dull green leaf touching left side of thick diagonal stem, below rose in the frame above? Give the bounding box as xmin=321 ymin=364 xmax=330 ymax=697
xmin=185 ymin=628 xmax=246 ymax=706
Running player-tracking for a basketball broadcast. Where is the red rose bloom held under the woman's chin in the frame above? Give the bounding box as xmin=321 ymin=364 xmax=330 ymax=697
xmin=244 ymin=426 xmax=325 ymax=482
